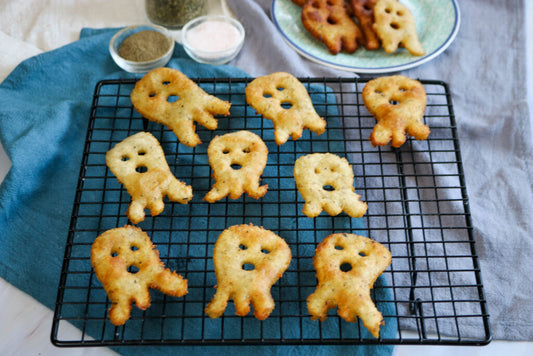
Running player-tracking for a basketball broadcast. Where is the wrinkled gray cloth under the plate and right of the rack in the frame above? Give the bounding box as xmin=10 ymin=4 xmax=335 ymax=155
xmin=228 ymin=0 xmax=533 ymax=340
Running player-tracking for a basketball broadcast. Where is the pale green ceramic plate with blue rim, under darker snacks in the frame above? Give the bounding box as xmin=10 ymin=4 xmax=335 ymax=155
xmin=272 ymin=0 xmax=461 ymax=73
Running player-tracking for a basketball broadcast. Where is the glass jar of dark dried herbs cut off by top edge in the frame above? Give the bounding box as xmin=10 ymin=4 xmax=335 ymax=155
xmin=145 ymin=0 xmax=206 ymax=28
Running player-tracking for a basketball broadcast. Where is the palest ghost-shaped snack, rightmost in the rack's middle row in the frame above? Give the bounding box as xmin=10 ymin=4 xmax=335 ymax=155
xmin=294 ymin=153 xmax=367 ymax=218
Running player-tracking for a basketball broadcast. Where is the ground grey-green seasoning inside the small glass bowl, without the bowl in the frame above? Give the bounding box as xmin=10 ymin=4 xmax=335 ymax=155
xmin=118 ymin=30 xmax=170 ymax=62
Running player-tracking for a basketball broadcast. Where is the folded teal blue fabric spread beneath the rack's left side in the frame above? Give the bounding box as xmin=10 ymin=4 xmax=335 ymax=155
xmin=0 ymin=29 xmax=396 ymax=355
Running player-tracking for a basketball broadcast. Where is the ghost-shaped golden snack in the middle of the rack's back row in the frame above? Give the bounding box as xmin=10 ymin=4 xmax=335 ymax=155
xmin=245 ymin=72 xmax=326 ymax=145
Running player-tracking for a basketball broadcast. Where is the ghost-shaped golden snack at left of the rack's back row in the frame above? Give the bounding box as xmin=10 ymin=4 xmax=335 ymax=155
xmin=131 ymin=68 xmax=231 ymax=147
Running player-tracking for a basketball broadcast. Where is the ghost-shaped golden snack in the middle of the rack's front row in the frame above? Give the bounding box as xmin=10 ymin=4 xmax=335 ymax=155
xmin=205 ymin=224 xmax=291 ymax=320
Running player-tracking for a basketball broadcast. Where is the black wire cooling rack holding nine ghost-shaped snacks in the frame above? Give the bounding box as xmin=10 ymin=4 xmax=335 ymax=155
xmin=51 ymin=78 xmax=491 ymax=346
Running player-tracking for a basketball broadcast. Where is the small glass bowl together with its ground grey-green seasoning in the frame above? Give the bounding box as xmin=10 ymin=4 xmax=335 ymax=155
xmin=109 ymin=25 xmax=174 ymax=73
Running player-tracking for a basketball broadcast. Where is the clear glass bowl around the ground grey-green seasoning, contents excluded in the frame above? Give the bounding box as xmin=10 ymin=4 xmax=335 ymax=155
xmin=109 ymin=25 xmax=174 ymax=73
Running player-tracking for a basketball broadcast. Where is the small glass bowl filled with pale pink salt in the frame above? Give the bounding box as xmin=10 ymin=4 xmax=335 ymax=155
xmin=181 ymin=15 xmax=245 ymax=65
